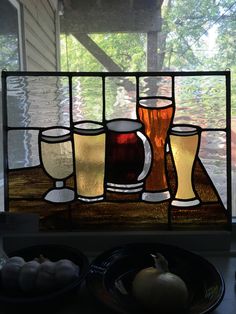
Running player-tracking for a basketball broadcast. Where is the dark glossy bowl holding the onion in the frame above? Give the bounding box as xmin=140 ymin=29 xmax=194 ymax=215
xmin=86 ymin=243 xmax=225 ymax=314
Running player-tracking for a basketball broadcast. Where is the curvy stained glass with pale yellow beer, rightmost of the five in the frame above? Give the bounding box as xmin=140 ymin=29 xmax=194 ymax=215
xmin=170 ymin=124 xmax=201 ymax=207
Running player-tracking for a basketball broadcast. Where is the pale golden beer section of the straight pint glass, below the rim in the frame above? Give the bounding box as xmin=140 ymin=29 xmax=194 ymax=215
xmin=74 ymin=133 xmax=105 ymax=197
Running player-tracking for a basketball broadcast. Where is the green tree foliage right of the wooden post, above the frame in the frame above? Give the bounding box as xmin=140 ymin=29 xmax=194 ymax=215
xmin=162 ymin=0 xmax=236 ymax=115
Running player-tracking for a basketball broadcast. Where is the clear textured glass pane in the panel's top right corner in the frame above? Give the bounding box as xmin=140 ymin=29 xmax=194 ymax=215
xmin=174 ymin=76 xmax=226 ymax=128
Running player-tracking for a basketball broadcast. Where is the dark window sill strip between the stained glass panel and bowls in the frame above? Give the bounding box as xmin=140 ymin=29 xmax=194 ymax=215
xmin=3 ymin=231 xmax=236 ymax=256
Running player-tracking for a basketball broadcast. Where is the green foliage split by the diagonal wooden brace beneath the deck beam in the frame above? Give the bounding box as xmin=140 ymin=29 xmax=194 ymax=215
xmin=61 ymin=33 xmax=146 ymax=72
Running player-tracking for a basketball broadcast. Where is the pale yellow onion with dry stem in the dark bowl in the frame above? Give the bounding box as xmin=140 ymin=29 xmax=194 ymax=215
xmin=132 ymin=254 xmax=188 ymax=314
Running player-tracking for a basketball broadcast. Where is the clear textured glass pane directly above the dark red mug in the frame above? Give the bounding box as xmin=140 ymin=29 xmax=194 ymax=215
xmin=106 ymin=77 xmax=137 ymax=120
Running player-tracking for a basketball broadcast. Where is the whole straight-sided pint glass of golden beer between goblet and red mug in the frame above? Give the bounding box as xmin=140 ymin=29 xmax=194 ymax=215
xmin=73 ymin=122 xmax=105 ymax=202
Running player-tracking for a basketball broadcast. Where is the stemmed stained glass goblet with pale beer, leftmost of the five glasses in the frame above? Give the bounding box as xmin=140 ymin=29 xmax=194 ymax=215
xmin=39 ymin=127 xmax=74 ymax=203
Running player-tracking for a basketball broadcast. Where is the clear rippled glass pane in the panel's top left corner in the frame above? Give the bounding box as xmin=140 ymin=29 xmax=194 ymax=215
xmin=7 ymin=76 xmax=69 ymax=127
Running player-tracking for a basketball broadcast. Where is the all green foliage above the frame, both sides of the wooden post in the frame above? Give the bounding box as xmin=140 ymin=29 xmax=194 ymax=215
xmin=61 ymin=0 xmax=236 ymax=115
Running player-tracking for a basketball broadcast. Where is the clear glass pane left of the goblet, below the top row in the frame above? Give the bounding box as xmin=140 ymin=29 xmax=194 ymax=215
xmin=8 ymin=130 xmax=40 ymax=169
